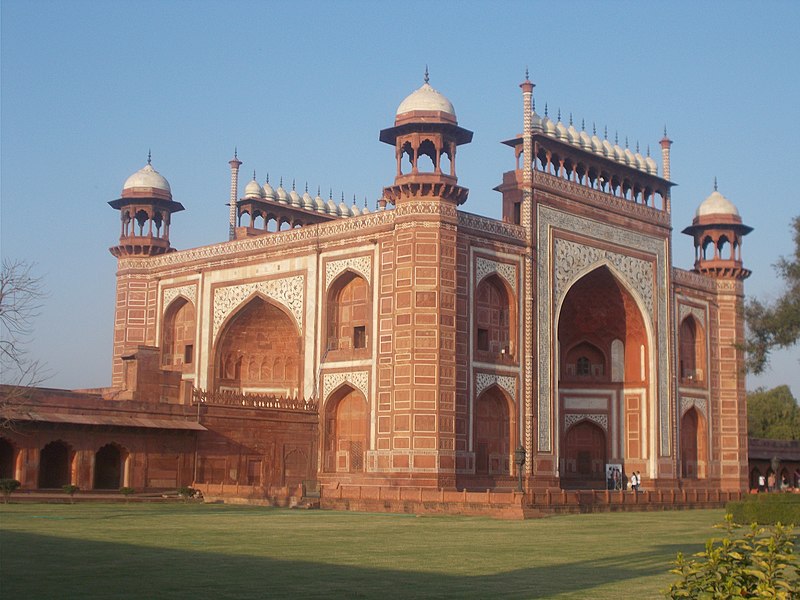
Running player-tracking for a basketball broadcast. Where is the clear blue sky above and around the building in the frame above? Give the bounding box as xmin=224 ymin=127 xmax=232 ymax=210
xmin=0 ymin=0 xmax=800 ymax=397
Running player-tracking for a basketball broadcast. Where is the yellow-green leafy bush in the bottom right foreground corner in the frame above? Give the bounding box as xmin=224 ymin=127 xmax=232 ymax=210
xmin=665 ymin=514 xmax=800 ymax=600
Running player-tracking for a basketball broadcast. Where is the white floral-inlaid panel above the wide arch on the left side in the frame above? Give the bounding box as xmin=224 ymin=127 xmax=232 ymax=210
xmin=212 ymin=275 xmax=305 ymax=339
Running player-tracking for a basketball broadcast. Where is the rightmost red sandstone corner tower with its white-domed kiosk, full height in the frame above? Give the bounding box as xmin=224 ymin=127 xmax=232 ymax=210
xmin=683 ymin=186 xmax=753 ymax=491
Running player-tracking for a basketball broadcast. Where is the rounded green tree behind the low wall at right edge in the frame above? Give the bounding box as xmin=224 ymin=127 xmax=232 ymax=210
xmin=747 ymin=385 xmax=800 ymax=440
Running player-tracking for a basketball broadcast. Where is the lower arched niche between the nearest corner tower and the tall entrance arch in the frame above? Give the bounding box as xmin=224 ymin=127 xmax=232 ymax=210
xmin=473 ymin=387 xmax=511 ymax=475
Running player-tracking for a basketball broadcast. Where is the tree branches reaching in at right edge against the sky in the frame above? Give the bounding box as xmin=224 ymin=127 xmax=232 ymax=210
xmin=744 ymin=216 xmax=800 ymax=374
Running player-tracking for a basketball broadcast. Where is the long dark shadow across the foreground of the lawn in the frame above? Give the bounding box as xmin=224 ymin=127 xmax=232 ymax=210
xmin=0 ymin=531 xmax=686 ymax=600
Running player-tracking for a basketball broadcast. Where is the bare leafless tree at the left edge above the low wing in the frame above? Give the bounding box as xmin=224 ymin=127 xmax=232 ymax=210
xmin=0 ymin=258 xmax=46 ymax=427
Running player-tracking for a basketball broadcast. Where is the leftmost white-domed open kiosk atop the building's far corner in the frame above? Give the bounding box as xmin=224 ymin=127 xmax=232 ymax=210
xmin=108 ymin=152 xmax=183 ymax=258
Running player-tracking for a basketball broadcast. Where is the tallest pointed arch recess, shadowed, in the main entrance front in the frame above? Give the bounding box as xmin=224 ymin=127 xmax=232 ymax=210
xmin=558 ymin=266 xmax=651 ymax=487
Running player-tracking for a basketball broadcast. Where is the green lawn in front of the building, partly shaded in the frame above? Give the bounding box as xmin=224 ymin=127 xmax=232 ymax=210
xmin=0 ymin=504 xmax=723 ymax=600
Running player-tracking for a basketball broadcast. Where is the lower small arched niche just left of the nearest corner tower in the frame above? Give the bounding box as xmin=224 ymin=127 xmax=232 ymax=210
xmin=324 ymin=386 xmax=369 ymax=473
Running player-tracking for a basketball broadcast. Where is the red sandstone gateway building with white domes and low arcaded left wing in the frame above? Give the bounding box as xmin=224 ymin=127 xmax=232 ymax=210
xmin=0 ymin=79 xmax=750 ymax=510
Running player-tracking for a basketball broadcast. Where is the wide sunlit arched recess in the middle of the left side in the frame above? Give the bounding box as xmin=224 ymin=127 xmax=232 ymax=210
xmin=214 ymin=297 xmax=302 ymax=397
